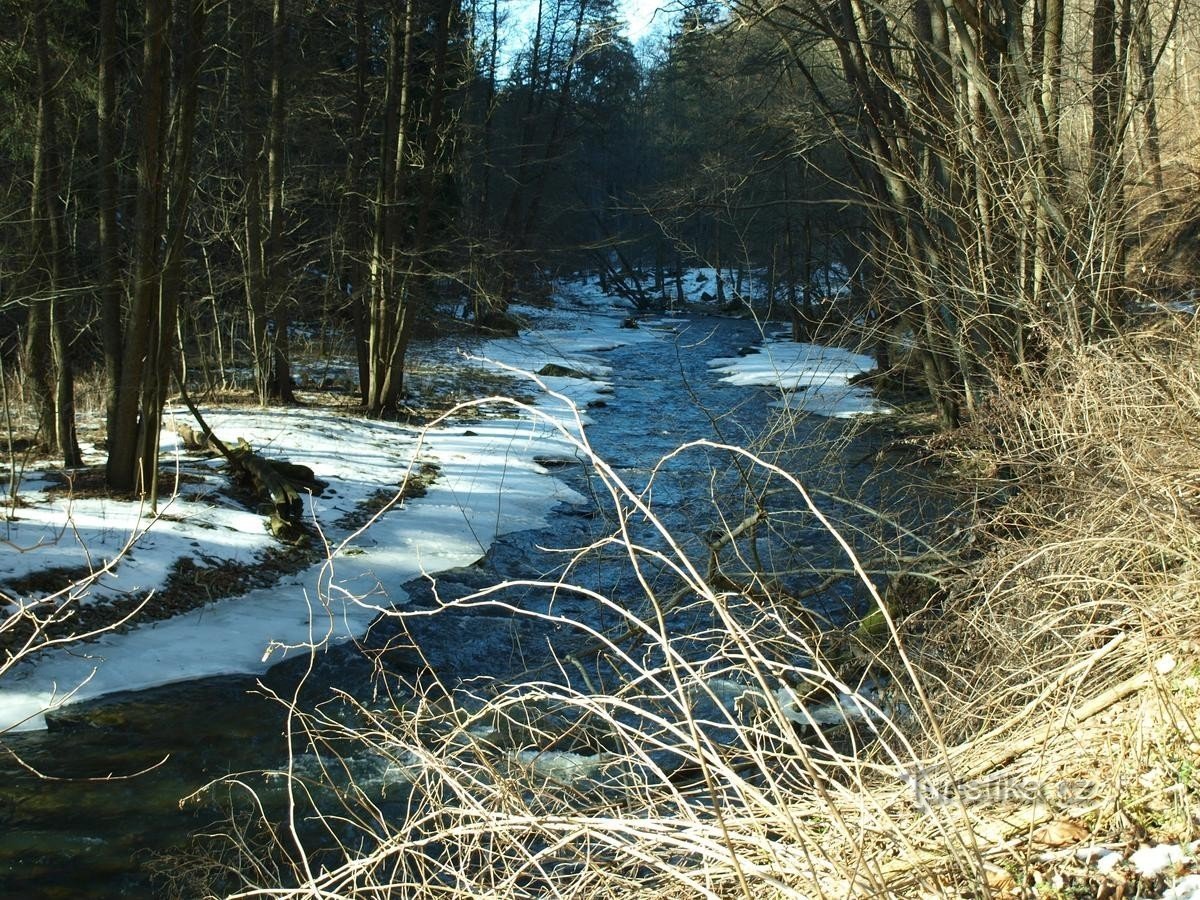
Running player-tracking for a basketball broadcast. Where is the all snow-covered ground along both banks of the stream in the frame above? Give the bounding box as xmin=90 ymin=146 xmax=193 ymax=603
xmin=0 ymin=278 xmax=872 ymax=733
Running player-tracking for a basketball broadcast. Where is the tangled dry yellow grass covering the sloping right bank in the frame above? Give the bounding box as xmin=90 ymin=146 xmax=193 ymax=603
xmin=859 ymin=322 xmax=1200 ymax=896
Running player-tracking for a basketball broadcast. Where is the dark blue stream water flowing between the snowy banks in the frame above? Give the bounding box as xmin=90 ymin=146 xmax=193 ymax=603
xmin=0 ymin=319 xmax=916 ymax=898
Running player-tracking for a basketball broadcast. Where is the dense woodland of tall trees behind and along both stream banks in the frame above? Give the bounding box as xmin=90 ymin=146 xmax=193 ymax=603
xmin=0 ymin=0 xmax=1200 ymax=493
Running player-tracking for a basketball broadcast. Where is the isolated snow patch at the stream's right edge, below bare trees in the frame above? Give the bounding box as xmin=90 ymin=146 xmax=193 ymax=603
xmin=709 ymin=341 xmax=892 ymax=419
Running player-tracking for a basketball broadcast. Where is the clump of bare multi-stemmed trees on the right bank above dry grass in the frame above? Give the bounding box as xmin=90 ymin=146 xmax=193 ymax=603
xmin=740 ymin=0 xmax=1176 ymax=426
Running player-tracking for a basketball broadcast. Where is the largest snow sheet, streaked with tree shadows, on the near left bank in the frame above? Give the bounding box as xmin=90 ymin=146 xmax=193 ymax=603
xmin=0 ymin=409 xmax=583 ymax=730
